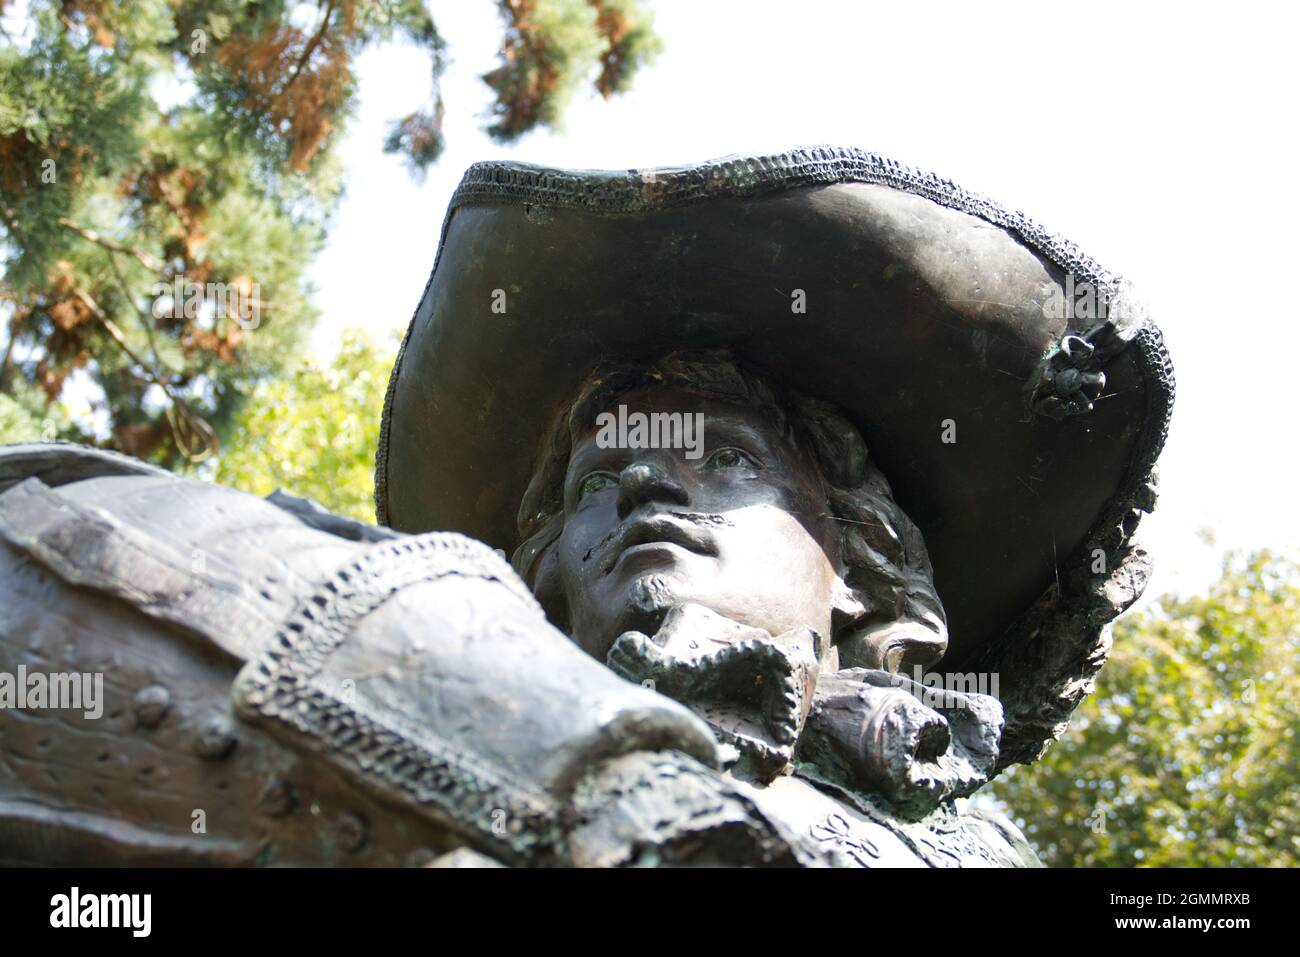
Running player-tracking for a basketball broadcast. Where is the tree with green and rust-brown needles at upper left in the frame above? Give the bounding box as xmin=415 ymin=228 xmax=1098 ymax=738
xmin=0 ymin=0 xmax=657 ymax=465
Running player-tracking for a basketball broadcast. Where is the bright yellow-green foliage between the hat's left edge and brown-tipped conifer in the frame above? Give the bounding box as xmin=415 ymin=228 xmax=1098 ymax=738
xmin=200 ymin=332 xmax=397 ymax=521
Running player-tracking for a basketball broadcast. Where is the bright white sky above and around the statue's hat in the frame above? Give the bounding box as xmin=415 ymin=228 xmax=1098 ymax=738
xmin=313 ymin=0 xmax=1300 ymax=596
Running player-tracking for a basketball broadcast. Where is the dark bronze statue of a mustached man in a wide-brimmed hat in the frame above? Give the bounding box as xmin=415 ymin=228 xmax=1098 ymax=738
xmin=0 ymin=148 xmax=1173 ymax=866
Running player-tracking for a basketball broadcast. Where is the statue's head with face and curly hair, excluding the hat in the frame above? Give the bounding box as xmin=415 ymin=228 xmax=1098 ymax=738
xmin=515 ymin=352 xmax=948 ymax=670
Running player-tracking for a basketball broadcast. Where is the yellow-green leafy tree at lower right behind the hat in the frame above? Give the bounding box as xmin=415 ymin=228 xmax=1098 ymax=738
xmin=993 ymin=551 xmax=1300 ymax=867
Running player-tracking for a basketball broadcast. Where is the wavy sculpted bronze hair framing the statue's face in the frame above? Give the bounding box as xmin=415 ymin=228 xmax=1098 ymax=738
xmin=511 ymin=352 xmax=948 ymax=671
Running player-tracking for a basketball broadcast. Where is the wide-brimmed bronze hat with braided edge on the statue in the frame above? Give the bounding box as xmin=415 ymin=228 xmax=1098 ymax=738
xmin=376 ymin=148 xmax=1173 ymax=753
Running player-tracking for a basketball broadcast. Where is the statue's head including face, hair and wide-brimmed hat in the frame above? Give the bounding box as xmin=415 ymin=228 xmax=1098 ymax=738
xmin=376 ymin=147 xmax=1173 ymax=762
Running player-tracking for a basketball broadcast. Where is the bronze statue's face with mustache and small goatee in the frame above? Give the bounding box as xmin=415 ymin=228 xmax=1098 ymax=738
xmin=556 ymin=386 xmax=839 ymax=661
